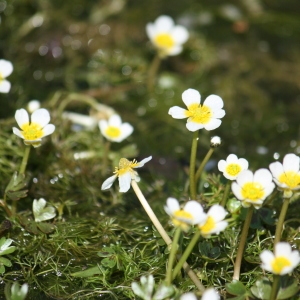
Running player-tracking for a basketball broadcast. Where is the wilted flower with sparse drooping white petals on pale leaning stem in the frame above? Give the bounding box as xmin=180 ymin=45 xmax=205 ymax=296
xmin=101 ymin=156 xmax=152 ymax=193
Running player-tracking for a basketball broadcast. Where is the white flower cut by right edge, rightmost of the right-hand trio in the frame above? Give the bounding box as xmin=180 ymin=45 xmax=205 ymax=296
xmin=269 ymin=153 xmax=300 ymax=198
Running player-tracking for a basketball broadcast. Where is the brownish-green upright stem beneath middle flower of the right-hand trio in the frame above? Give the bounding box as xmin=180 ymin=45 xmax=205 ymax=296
xmin=233 ymin=205 xmax=254 ymax=280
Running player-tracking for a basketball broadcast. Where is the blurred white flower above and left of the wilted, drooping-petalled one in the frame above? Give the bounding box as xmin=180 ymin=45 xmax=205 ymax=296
xmin=99 ymin=115 xmax=133 ymax=143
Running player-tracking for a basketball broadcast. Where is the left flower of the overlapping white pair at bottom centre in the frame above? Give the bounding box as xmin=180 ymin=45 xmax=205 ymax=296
xmin=164 ymin=197 xmax=206 ymax=231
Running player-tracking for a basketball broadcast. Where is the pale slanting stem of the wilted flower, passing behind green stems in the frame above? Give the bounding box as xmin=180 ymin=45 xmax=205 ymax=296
xmin=131 ymin=180 xmax=205 ymax=292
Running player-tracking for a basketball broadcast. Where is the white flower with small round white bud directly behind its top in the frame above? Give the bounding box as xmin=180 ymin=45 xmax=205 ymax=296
xmin=13 ymin=108 xmax=55 ymax=148
